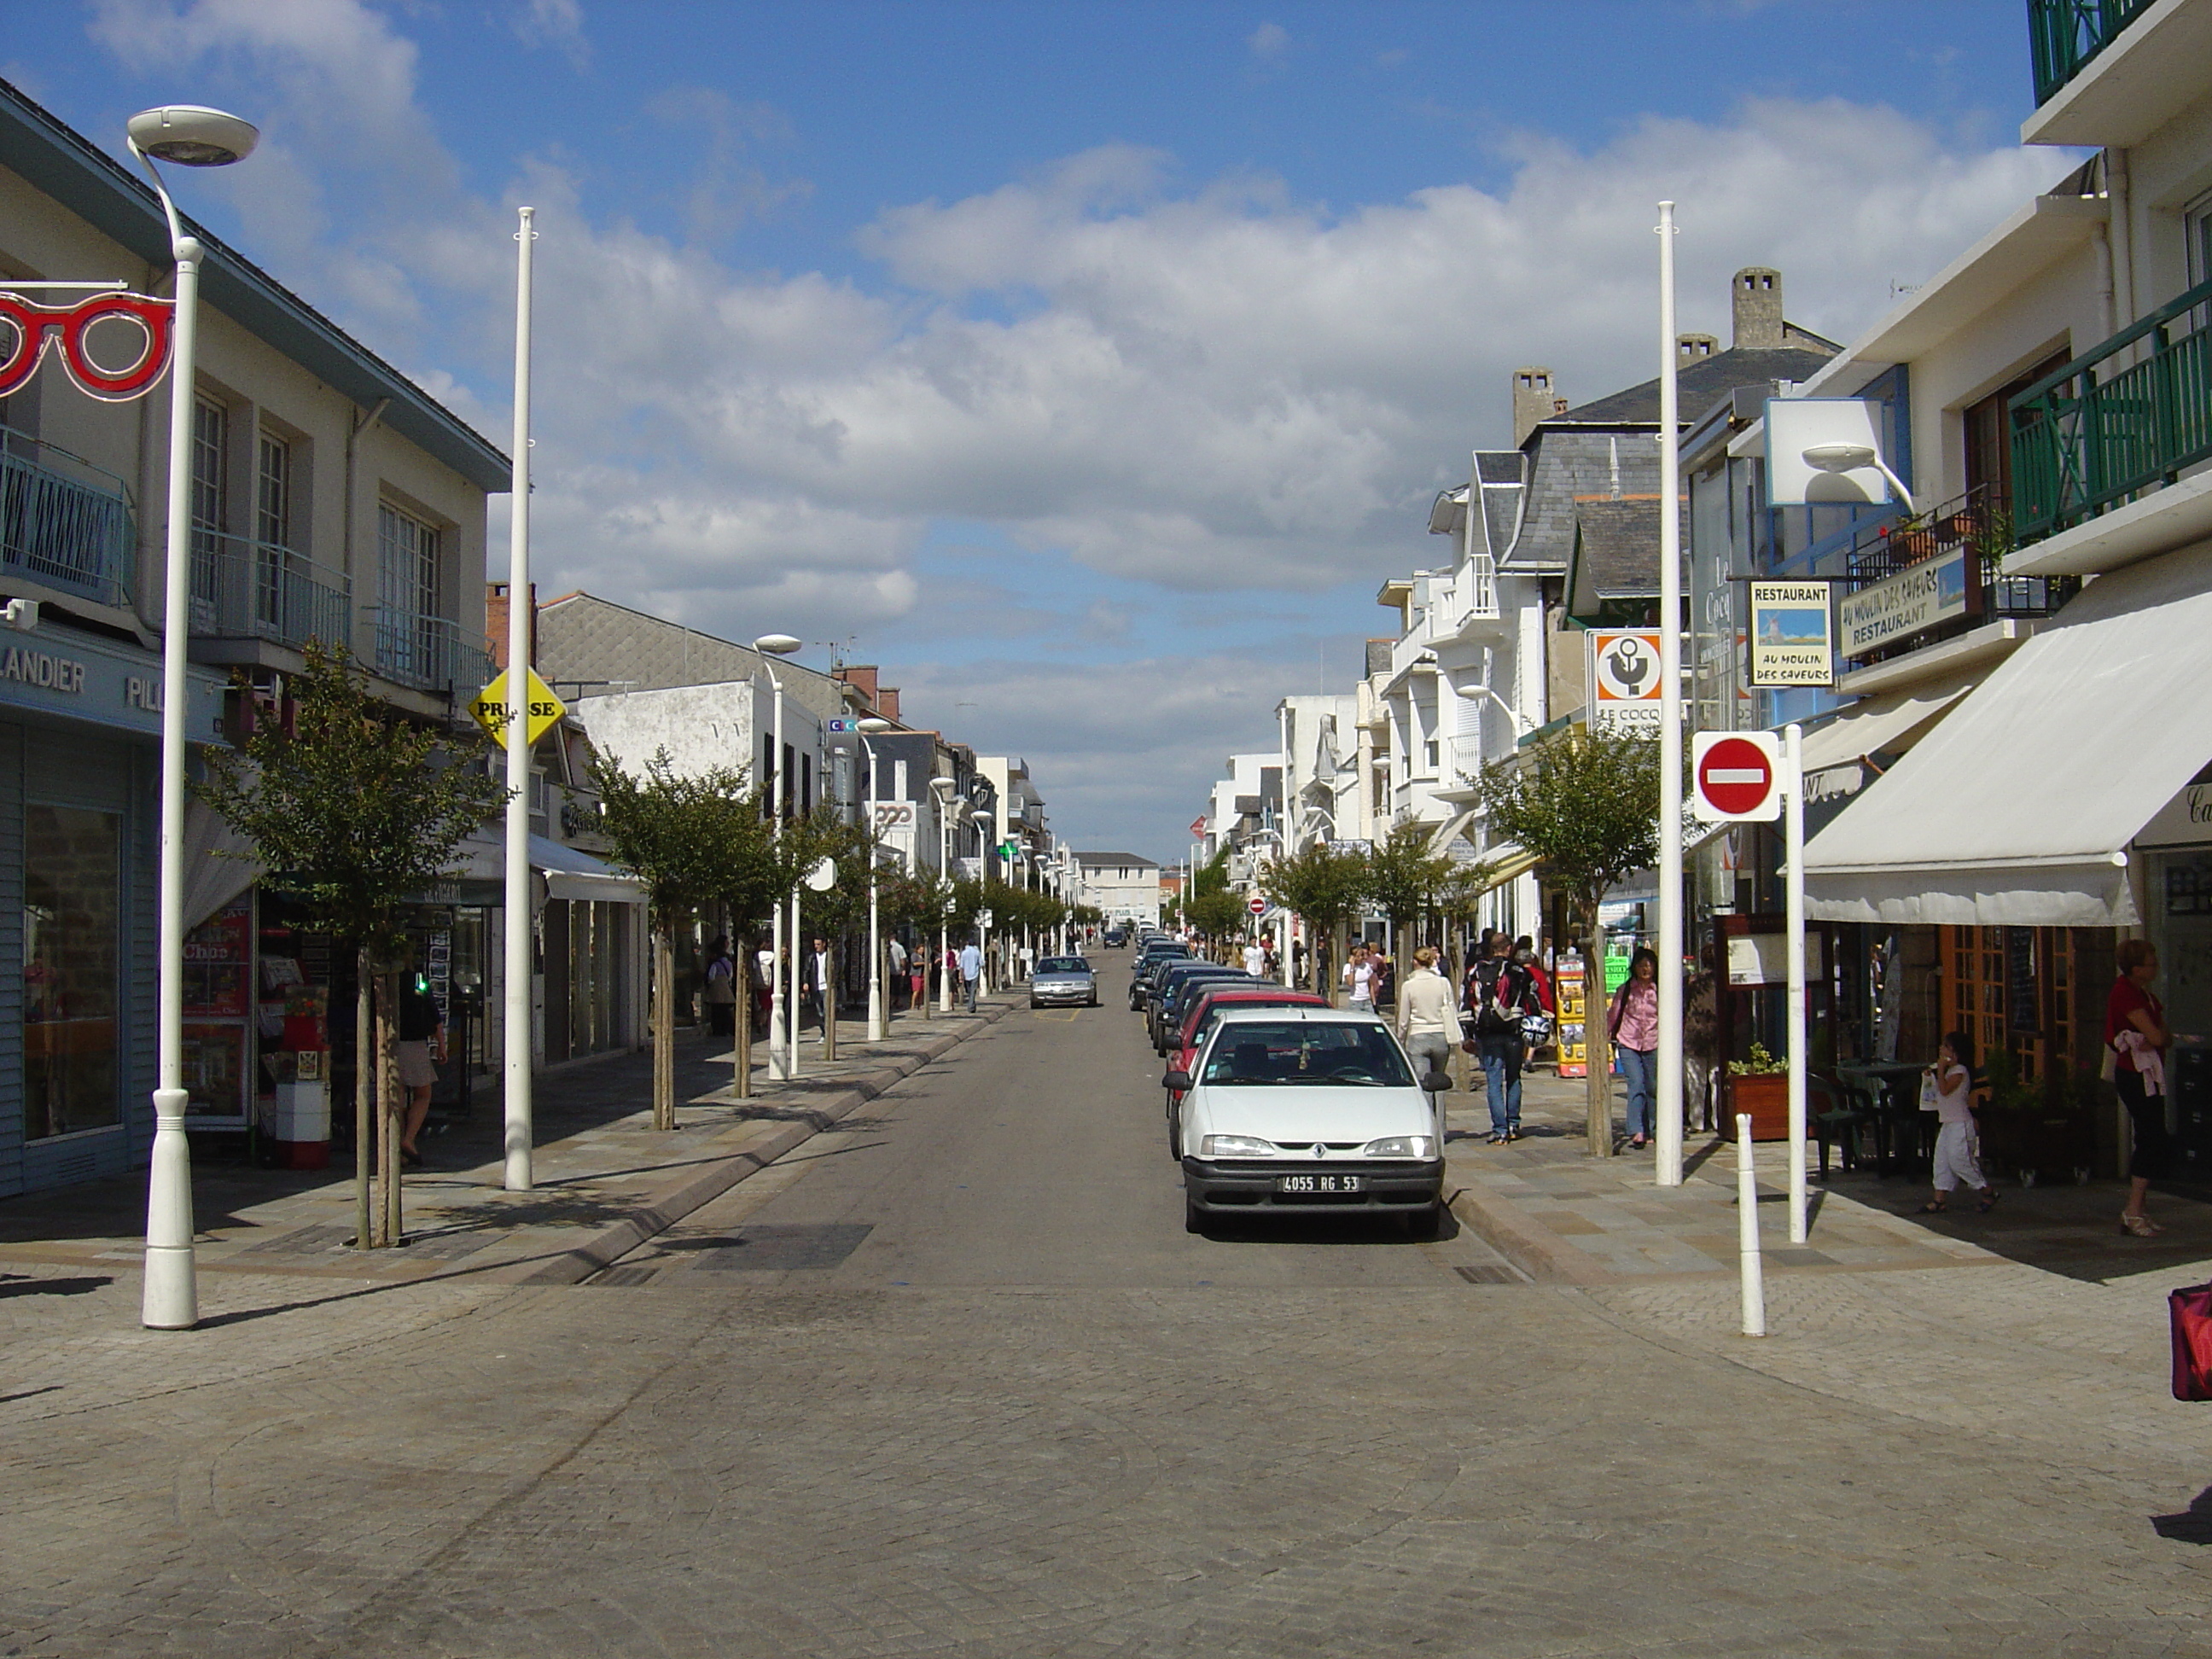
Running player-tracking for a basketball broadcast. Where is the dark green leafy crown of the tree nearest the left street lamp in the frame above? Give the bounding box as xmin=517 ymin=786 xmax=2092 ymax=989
xmin=193 ymin=642 xmax=507 ymax=960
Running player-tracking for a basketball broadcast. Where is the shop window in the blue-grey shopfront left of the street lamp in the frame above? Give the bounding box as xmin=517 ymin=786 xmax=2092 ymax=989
xmin=22 ymin=805 xmax=124 ymax=1141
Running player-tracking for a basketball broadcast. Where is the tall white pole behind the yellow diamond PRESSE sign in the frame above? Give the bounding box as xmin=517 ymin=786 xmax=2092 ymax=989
xmin=500 ymin=208 xmax=537 ymax=1192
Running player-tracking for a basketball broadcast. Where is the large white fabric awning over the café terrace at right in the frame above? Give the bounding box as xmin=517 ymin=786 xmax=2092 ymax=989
xmin=1805 ymin=546 xmax=2212 ymax=927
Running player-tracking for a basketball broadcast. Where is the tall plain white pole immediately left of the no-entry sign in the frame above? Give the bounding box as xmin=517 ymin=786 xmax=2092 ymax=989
xmin=1652 ymin=201 xmax=1681 ymax=1185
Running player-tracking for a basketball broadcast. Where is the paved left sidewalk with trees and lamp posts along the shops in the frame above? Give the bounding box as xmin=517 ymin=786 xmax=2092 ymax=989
xmin=0 ymin=995 xmax=1016 ymax=1285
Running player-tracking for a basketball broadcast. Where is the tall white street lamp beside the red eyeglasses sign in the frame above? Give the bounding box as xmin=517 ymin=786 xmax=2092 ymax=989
xmin=126 ymin=104 xmax=257 ymax=1331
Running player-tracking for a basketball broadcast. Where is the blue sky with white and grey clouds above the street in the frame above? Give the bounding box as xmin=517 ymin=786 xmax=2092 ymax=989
xmin=0 ymin=0 xmax=2077 ymax=860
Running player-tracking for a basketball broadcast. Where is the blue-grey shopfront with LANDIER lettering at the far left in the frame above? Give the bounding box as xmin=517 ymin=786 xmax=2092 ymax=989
xmin=0 ymin=621 xmax=224 ymax=1196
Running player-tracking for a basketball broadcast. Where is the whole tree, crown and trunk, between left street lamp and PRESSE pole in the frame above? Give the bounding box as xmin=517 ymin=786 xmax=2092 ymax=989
xmin=193 ymin=639 xmax=502 ymax=1248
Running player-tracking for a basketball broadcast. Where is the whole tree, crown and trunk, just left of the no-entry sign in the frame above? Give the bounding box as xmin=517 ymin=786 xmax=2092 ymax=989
xmin=1482 ymin=728 xmax=1659 ymax=1157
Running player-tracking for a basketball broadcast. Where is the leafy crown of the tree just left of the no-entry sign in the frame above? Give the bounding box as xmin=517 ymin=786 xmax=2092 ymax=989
xmin=1482 ymin=728 xmax=1659 ymax=913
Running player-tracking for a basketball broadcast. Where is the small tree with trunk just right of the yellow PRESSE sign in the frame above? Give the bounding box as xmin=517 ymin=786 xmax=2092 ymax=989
xmin=593 ymin=750 xmax=770 ymax=1128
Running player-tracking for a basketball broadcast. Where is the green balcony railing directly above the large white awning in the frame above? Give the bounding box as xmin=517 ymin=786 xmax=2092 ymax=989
xmin=2011 ymin=283 xmax=2212 ymax=542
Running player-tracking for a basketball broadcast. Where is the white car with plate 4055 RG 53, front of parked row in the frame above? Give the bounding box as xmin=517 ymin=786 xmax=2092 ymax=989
xmin=1166 ymin=1009 xmax=1445 ymax=1239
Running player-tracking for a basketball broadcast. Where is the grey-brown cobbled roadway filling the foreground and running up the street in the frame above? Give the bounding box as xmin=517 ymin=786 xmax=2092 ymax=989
xmin=0 ymin=969 xmax=2212 ymax=1659
